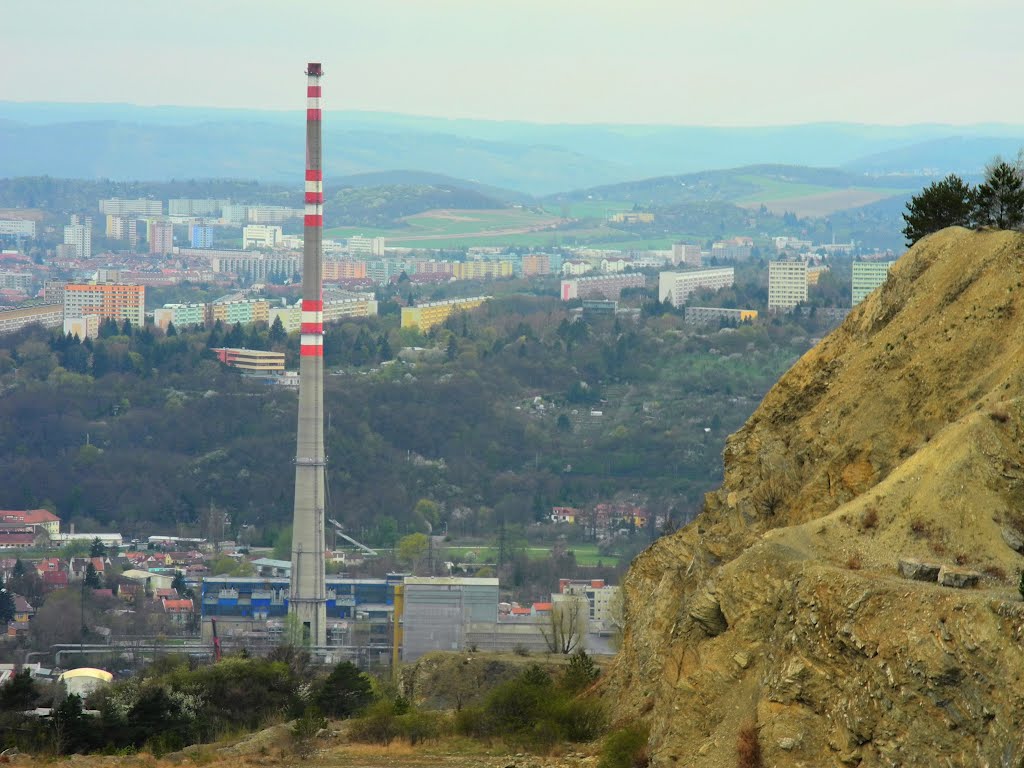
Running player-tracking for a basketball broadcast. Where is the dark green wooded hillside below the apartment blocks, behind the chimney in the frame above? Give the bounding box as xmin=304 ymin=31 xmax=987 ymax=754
xmin=0 ymin=297 xmax=823 ymax=543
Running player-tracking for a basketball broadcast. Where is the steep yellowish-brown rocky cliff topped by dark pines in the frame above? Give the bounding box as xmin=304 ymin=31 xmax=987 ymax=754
xmin=608 ymin=229 xmax=1024 ymax=768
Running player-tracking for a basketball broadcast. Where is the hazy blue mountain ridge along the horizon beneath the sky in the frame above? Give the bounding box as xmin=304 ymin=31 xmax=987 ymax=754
xmin=0 ymin=101 xmax=1024 ymax=195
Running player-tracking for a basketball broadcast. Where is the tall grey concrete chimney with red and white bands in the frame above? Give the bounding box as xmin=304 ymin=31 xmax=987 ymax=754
xmin=289 ymin=63 xmax=327 ymax=645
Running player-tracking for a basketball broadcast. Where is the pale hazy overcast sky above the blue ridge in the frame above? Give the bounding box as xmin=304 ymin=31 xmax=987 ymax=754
xmin=0 ymin=0 xmax=1024 ymax=125
